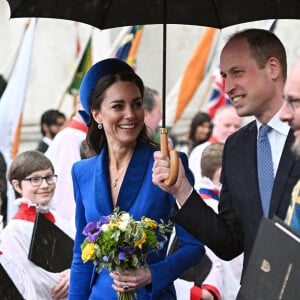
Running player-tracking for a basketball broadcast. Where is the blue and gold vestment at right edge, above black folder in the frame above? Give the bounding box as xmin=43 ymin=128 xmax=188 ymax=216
xmin=285 ymin=180 xmax=300 ymax=233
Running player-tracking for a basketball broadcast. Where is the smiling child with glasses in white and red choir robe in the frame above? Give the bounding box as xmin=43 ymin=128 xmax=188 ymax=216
xmin=0 ymin=151 xmax=73 ymax=300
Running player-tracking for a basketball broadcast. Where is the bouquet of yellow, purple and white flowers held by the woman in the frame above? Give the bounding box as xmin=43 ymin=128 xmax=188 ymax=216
xmin=81 ymin=208 xmax=173 ymax=300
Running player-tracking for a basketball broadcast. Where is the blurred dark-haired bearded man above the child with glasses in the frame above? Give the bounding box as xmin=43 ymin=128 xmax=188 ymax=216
xmin=36 ymin=109 xmax=66 ymax=153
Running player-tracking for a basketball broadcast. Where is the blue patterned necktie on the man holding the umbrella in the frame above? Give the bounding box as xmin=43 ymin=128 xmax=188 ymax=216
xmin=257 ymin=124 xmax=274 ymax=217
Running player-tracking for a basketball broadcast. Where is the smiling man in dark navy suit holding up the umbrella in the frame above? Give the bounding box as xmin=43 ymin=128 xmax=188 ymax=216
xmin=152 ymin=29 xmax=300 ymax=288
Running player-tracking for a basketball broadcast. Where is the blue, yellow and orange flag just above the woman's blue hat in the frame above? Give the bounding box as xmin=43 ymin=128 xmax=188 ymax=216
xmin=115 ymin=25 xmax=143 ymax=69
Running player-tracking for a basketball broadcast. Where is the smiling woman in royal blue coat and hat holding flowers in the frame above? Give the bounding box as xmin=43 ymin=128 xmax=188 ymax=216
xmin=69 ymin=59 xmax=204 ymax=300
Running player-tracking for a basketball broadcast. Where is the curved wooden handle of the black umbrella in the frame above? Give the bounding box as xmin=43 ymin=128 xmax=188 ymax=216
xmin=160 ymin=128 xmax=179 ymax=186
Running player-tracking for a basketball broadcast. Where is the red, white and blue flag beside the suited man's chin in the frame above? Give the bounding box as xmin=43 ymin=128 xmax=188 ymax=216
xmin=207 ymin=68 xmax=230 ymax=119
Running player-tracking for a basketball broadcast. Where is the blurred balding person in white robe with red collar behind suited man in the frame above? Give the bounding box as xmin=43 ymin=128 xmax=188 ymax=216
xmin=189 ymin=104 xmax=243 ymax=191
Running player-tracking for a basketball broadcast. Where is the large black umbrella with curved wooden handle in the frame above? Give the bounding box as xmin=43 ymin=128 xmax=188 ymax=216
xmin=7 ymin=0 xmax=300 ymax=185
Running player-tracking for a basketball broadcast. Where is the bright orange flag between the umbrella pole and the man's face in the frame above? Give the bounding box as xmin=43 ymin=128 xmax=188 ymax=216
xmin=174 ymin=28 xmax=217 ymax=123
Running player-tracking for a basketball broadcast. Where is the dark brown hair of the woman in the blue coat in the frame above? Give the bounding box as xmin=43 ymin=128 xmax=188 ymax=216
xmin=86 ymin=72 xmax=158 ymax=154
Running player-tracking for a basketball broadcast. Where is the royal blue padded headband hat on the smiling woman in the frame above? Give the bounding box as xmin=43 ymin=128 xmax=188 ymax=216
xmin=79 ymin=58 xmax=134 ymax=124
